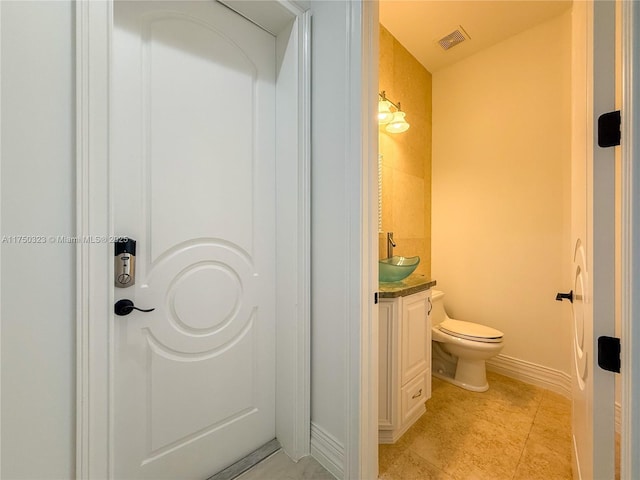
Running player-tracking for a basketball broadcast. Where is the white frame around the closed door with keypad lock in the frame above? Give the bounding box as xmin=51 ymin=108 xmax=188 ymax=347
xmin=75 ymin=0 xmax=311 ymax=480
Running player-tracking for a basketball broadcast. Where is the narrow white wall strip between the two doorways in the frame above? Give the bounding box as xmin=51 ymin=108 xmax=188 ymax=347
xmin=311 ymin=1 xmax=349 ymax=460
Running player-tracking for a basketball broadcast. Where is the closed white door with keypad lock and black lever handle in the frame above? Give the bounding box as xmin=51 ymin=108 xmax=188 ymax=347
xmin=110 ymin=1 xmax=276 ymax=479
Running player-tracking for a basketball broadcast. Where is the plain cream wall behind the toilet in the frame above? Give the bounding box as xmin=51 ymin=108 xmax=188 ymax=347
xmin=432 ymin=12 xmax=572 ymax=373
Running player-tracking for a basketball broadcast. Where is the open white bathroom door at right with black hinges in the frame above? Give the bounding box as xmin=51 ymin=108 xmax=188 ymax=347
xmin=572 ymin=1 xmax=615 ymax=480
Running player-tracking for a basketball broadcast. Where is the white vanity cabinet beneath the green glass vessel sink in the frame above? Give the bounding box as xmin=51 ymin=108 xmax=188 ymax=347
xmin=378 ymin=290 xmax=431 ymax=443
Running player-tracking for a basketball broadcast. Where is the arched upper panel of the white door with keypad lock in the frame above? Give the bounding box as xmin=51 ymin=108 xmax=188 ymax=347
xmin=142 ymin=15 xmax=256 ymax=262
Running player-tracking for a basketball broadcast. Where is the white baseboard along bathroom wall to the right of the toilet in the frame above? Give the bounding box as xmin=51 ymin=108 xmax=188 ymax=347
xmin=487 ymin=354 xmax=571 ymax=399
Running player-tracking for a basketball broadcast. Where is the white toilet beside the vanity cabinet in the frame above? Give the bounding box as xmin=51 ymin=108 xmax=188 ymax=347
xmin=431 ymin=290 xmax=504 ymax=392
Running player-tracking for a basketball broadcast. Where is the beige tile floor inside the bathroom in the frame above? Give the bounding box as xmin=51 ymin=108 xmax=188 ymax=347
xmin=379 ymin=372 xmax=572 ymax=480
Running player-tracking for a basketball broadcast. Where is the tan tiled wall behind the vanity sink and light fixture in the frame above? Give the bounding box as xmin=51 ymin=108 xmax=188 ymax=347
xmin=379 ymin=25 xmax=431 ymax=275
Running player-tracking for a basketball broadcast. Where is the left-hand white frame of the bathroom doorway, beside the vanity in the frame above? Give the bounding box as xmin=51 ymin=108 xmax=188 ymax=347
xmin=343 ymin=0 xmax=379 ymax=479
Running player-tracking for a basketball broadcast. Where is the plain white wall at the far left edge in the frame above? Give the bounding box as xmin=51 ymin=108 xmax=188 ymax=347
xmin=0 ymin=1 xmax=75 ymax=480
